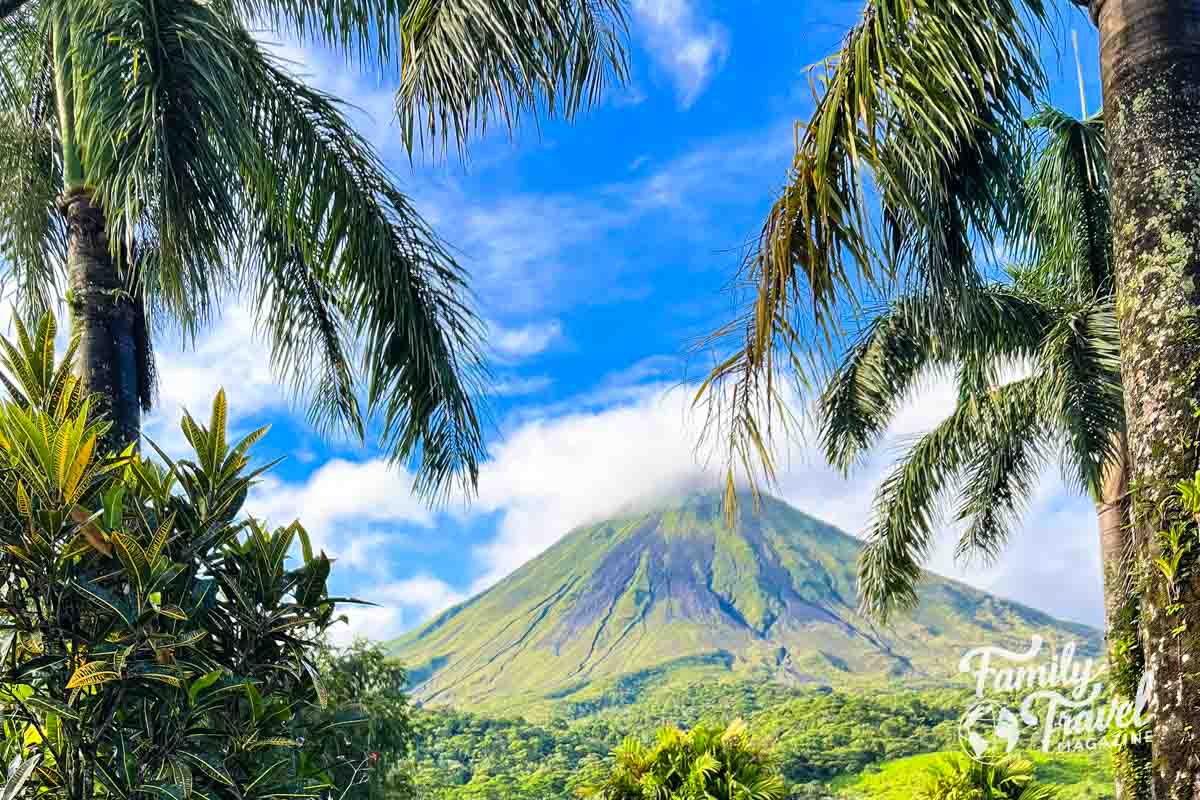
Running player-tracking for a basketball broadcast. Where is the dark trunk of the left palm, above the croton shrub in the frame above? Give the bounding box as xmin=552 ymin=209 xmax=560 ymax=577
xmin=61 ymin=190 xmax=142 ymax=451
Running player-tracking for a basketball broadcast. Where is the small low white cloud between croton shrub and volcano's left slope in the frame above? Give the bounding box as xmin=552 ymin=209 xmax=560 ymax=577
xmin=330 ymin=575 xmax=467 ymax=645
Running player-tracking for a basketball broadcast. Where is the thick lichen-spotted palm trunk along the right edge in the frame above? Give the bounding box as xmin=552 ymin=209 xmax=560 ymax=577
xmin=1091 ymin=0 xmax=1200 ymax=800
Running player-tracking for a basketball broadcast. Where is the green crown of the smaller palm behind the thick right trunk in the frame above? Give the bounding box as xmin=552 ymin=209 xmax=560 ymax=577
xmin=821 ymin=108 xmax=1124 ymax=618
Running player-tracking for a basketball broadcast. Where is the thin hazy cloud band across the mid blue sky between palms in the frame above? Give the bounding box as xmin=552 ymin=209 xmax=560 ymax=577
xmin=416 ymin=121 xmax=793 ymax=319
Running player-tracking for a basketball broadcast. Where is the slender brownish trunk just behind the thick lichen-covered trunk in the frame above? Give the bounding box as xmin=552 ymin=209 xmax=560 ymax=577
xmin=1096 ymin=434 xmax=1151 ymax=800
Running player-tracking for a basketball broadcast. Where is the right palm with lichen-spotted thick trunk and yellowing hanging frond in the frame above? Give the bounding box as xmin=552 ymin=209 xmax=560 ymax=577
xmin=700 ymin=0 xmax=1200 ymax=796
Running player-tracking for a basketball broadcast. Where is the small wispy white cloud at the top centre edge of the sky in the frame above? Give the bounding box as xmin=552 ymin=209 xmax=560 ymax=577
xmin=632 ymin=0 xmax=730 ymax=108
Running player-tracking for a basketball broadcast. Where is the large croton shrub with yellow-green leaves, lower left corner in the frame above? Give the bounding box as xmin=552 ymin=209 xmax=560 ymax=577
xmin=0 ymin=317 xmax=370 ymax=800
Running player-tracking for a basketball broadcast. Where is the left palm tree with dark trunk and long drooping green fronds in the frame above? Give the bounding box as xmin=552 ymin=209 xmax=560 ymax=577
xmin=0 ymin=0 xmax=624 ymax=491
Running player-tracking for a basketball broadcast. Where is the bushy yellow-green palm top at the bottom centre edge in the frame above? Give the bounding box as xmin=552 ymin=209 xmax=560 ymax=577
xmin=582 ymin=720 xmax=787 ymax=800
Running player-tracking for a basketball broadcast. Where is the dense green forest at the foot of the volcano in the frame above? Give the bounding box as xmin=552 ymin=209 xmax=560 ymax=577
xmin=412 ymin=681 xmax=968 ymax=800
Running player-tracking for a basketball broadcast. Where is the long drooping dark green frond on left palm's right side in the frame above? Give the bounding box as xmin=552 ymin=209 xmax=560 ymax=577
xmin=242 ymin=43 xmax=484 ymax=494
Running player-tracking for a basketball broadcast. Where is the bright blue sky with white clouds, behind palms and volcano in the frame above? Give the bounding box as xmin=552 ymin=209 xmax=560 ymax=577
xmin=138 ymin=0 xmax=1102 ymax=639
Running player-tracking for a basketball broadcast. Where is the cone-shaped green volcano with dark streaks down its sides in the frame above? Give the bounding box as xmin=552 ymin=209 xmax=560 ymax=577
xmin=392 ymin=493 xmax=1100 ymax=710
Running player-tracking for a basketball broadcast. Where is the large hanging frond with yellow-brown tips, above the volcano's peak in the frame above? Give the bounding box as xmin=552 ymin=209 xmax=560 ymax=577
xmin=706 ymin=0 xmax=1045 ymax=494
